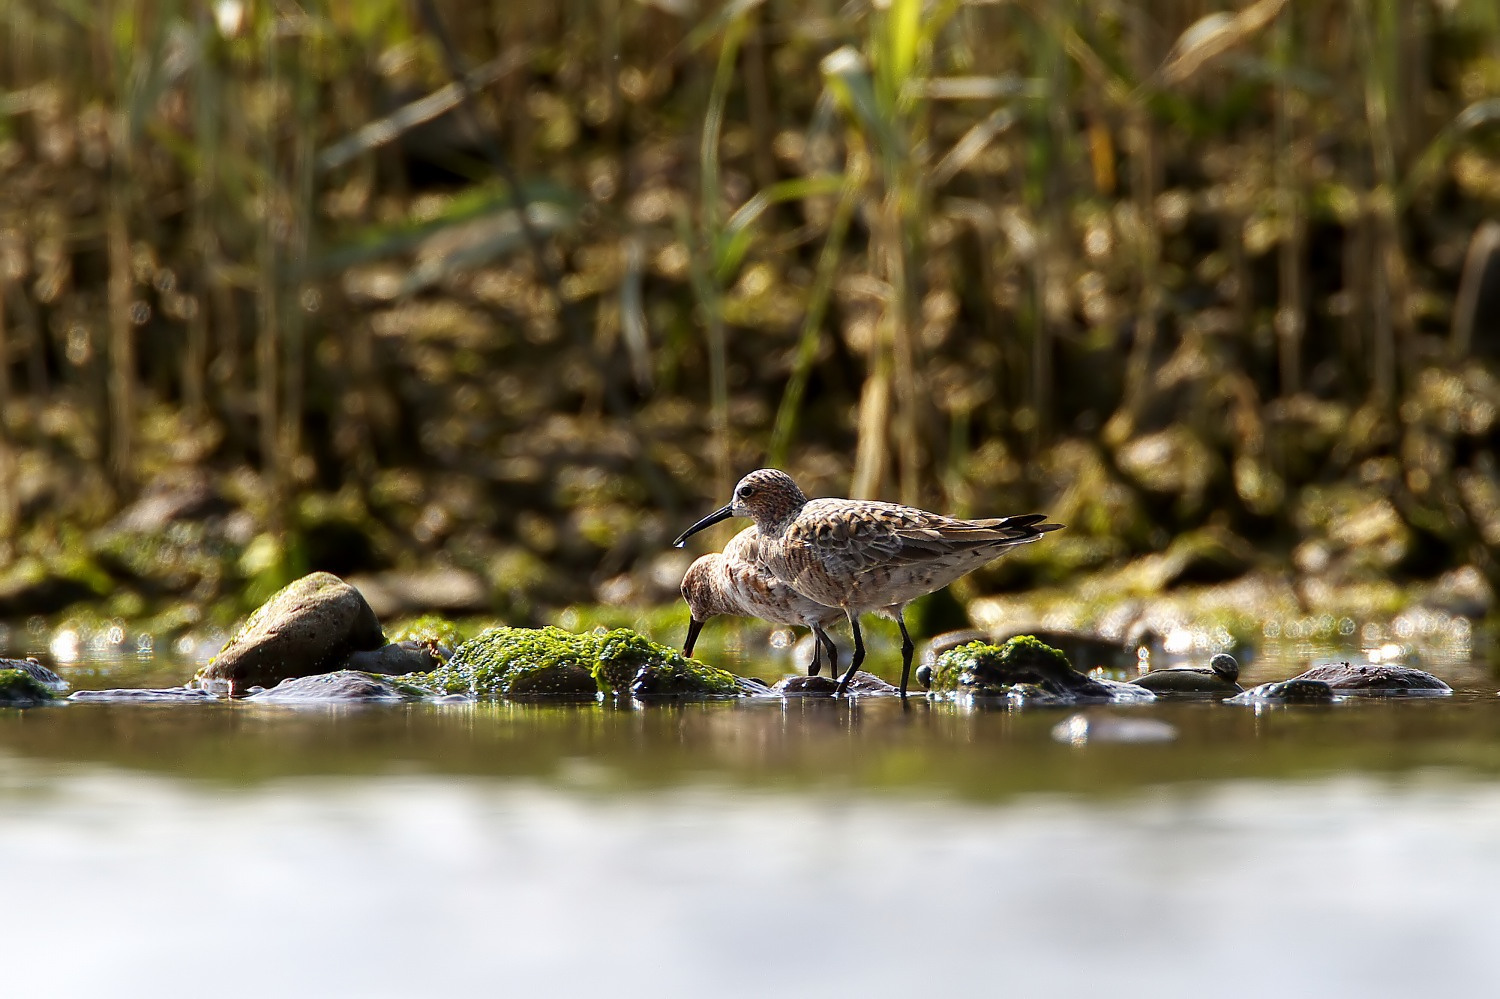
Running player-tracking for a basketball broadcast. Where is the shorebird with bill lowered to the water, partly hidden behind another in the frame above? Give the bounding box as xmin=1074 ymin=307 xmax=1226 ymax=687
xmin=683 ymin=527 xmax=843 ymax=677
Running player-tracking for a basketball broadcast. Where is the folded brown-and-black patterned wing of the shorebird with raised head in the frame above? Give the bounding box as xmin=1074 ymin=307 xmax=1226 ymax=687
xmin=788 ymin=501 xmax=1062 ymax=573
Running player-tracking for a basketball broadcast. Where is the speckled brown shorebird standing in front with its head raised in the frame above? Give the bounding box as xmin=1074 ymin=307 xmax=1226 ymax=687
xmin=674 ymin=468 xmax=1062 ymax=699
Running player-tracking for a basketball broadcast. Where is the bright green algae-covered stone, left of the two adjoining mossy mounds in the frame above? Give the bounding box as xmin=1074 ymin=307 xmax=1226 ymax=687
xmin=431 ymin=627 xmax=599 ymax=698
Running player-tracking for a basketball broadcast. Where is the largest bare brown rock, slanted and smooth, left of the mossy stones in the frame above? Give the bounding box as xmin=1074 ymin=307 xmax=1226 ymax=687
xmin=195 ymin=573 xmax=386 ymax=695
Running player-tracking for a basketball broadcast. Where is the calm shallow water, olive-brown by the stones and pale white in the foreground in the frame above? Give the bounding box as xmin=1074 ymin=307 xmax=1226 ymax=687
xmin=0 ymin=633 xmax=1500 ymax=996
